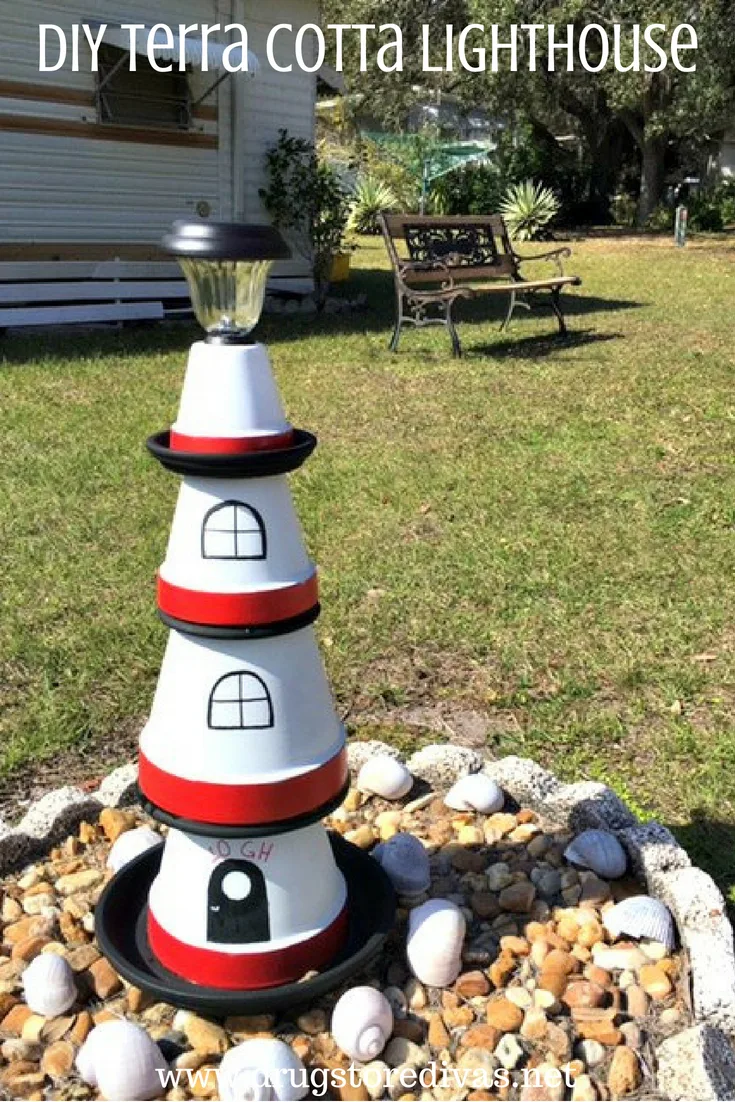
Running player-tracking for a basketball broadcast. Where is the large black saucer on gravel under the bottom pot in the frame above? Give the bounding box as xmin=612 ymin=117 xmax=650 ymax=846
xmin=95 ymin=834 xmax=396 ymax=1017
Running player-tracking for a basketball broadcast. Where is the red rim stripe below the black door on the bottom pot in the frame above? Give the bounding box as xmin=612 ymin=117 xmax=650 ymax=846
xmin=148 ymin=907 xmax=347 ymax=991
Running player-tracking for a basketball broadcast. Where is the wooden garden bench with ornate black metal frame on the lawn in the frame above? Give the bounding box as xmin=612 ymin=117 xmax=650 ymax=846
xmin=379 ymin=214 xmax=581 ymax=356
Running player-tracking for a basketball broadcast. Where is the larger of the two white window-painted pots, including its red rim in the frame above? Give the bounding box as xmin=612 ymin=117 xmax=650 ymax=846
xmin=140 ymin=627 xmax=347 ymax=825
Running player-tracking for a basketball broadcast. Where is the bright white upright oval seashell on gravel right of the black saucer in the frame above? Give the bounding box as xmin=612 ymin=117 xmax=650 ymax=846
xmin=407 ymin=899 xmax=466 ymax=987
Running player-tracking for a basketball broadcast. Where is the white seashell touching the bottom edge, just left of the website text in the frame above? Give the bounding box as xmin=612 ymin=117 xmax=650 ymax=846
xmin=76 ymin=1018 xmax=169 ymax=1102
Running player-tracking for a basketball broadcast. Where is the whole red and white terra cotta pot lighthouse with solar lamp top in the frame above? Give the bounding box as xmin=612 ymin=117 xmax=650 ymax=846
xmin=98 ymin=223 xmax=396 ymax=1002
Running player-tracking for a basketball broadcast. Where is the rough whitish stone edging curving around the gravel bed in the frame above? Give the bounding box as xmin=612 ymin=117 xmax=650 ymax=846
xmin=0 ymin=739 xmax=735 ymax=1102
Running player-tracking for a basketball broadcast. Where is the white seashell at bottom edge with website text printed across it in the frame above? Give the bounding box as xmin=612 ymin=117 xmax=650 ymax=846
xmin=217 ymin=1037 xmax=309 ymax=1102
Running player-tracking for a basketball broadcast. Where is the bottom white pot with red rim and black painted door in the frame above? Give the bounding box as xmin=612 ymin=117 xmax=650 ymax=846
xmin=149 ymin=823 xmax=347 ymax=988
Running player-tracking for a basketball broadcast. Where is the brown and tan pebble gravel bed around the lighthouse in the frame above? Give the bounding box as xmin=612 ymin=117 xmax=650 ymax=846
xmin=0 ymin=778 xmax=696 ymax=1102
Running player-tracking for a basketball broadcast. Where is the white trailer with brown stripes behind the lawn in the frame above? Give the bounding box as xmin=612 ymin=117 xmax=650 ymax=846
xmin=0 ymin=0 xmax=320 ymax=328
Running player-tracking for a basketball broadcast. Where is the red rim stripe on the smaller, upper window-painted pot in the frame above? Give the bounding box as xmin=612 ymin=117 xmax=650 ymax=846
xmin=158 ymin=572 xmax=318 ymax=627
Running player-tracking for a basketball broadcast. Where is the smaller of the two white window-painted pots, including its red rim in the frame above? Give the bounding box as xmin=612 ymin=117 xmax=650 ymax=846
xmin=159 ymin=476 xmax=317 ymax=626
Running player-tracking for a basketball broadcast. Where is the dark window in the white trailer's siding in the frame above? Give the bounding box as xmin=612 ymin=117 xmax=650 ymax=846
xmin=96 ymin=43 xmax=191 ymax=130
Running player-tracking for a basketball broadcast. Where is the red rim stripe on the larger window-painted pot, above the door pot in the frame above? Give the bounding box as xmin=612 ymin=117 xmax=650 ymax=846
xmin=138 ymin=749 xmax=347 ymax=827
